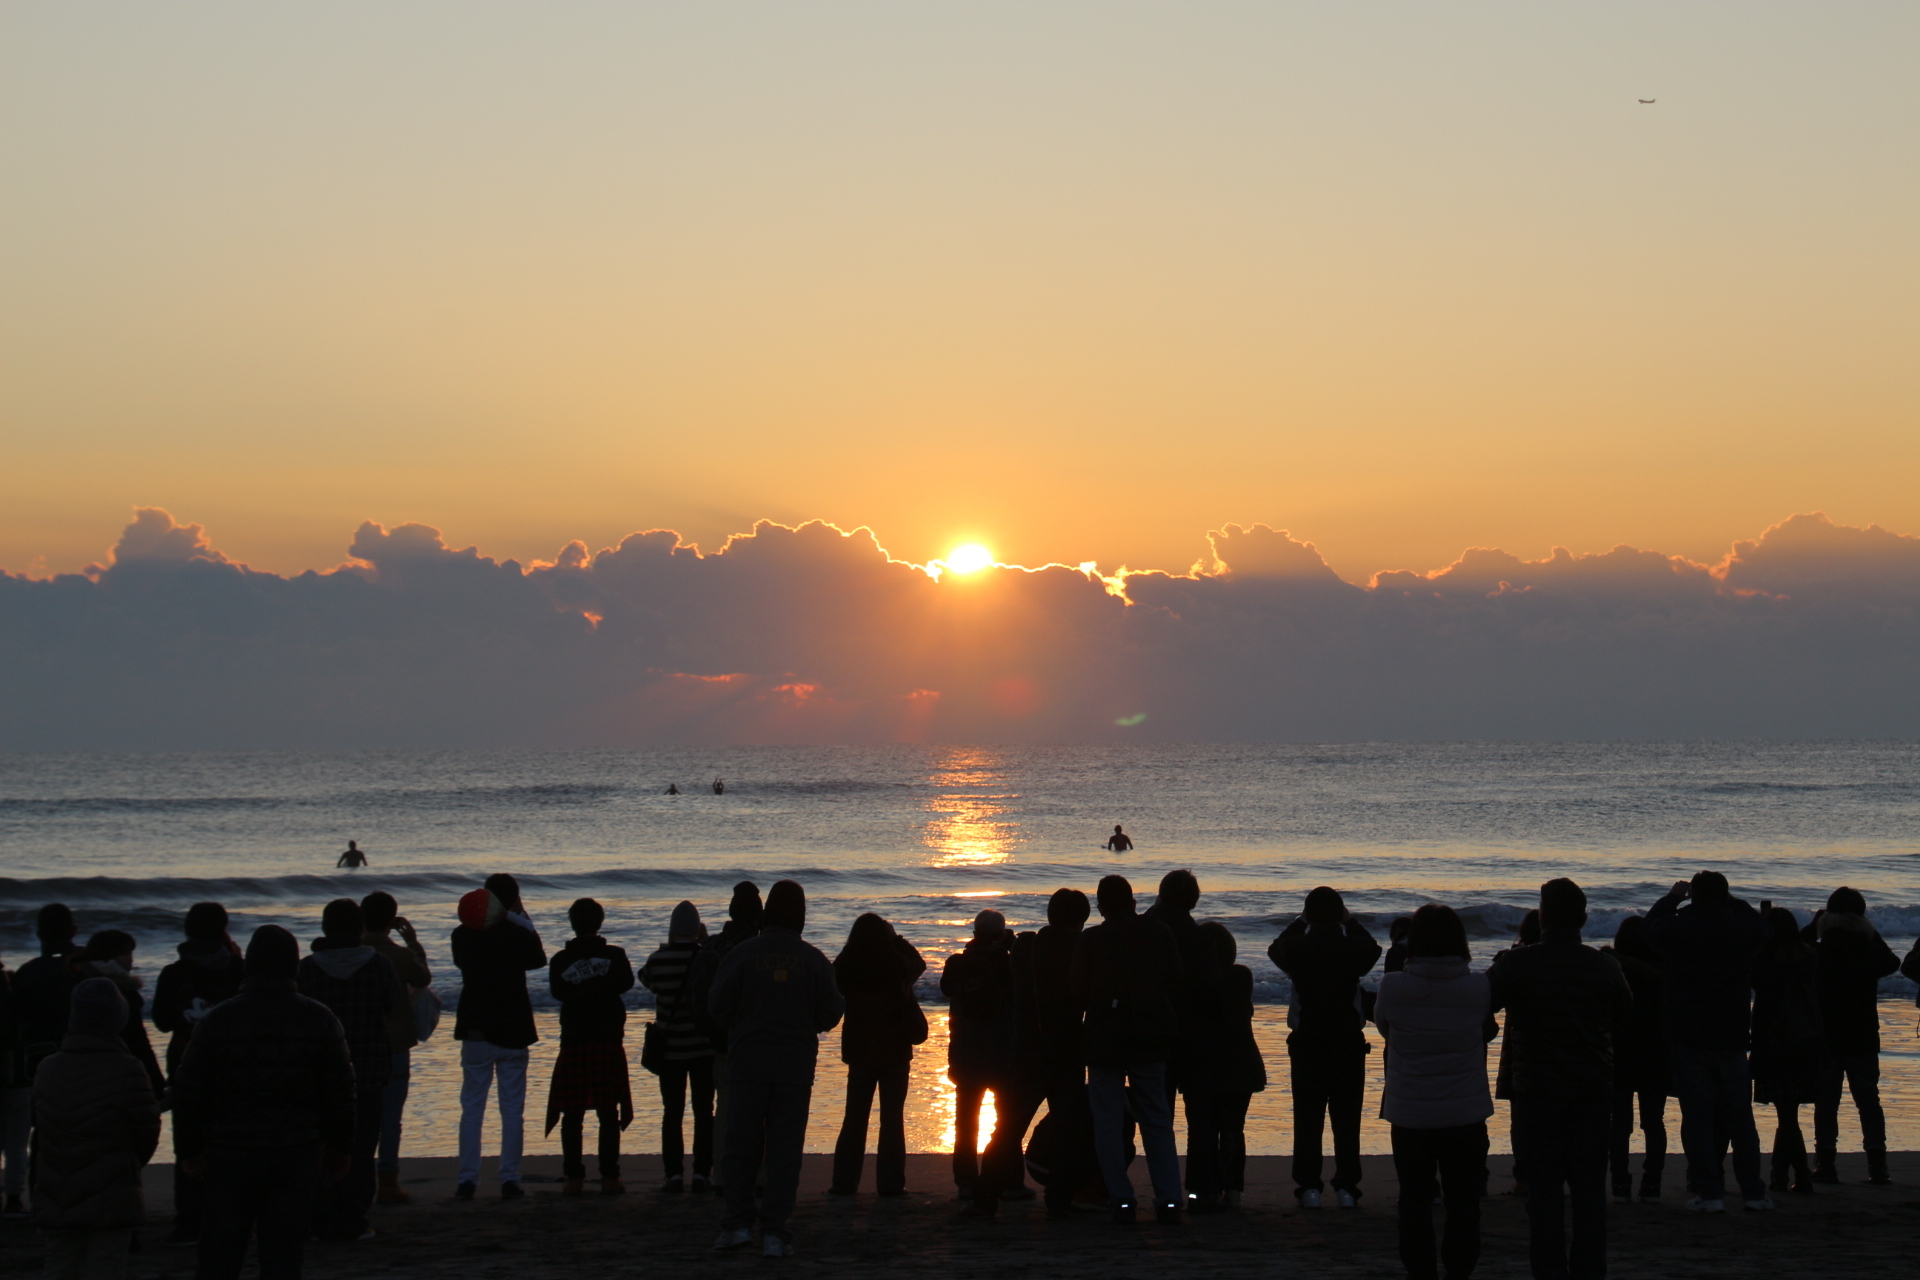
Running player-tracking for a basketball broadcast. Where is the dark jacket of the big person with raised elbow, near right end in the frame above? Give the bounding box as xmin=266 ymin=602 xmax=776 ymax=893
xmin=1647 ymin=894 xmax=1763 ymax=1050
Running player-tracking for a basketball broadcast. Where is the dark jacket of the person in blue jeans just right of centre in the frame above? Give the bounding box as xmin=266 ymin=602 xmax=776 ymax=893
xmin=1071 ymin=915 xmax=1185 ymax=1069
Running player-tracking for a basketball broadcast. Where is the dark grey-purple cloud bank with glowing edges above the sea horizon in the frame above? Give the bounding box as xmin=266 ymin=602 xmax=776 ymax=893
xmin=0 ymin=509 xmax=1920 ymax=750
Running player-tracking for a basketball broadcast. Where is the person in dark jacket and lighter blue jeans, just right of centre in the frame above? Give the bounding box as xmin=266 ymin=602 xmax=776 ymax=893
xmin=1071 ymin=875 xmax=1183 ymax=1224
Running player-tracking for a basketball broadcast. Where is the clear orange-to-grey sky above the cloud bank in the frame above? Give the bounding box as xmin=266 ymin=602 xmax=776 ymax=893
xmin=0 ymin=0 xmax=1920 ymax=587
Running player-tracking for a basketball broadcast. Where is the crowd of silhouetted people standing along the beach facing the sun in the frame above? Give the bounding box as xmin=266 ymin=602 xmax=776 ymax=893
xmin=0 ymin=871 xmax=1920 ymax=1280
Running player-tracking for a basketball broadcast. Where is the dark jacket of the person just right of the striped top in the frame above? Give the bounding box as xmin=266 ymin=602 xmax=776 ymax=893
xmin=708 ymin=925 xmax=847 ymax=1084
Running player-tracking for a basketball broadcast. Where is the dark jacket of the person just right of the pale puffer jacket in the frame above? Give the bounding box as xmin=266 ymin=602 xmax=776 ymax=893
xmin=1486 ymin=929 xmax=1634 ymax=1102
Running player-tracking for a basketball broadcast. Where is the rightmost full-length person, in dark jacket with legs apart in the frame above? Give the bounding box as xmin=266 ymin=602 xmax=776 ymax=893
xmin=1807 ymin=887 xmax=1901 ymax=1186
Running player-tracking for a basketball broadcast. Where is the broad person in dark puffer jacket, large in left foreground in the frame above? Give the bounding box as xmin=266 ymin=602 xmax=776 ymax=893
xmin=173 ymin=925 xmax=353 ymax=1280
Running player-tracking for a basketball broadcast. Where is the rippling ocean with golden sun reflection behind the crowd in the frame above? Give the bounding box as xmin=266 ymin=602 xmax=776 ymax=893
xmin=0 ymin=743 xmax=1920 ymax=1155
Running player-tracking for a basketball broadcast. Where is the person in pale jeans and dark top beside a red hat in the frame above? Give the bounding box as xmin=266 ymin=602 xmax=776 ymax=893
xmin=451 ymin=871 xmax=547 ymax=1199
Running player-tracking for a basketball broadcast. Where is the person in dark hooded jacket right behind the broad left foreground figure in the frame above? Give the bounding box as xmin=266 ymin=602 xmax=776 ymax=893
xmin=298 ymin=898 xmax=407 ymax=1240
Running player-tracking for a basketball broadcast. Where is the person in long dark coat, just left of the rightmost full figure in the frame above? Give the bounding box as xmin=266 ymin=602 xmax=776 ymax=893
xmin=1751 ymin=908 xmax=1826 ymax=1194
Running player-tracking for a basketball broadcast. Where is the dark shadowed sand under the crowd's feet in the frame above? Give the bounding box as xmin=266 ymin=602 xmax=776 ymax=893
xmin=0 ymin=1153 xmax=1920 ymax=1280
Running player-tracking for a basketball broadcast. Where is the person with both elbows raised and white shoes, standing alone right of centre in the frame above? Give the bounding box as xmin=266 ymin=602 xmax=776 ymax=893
xmin=1267 ymin=885 xmax=1380 ymax=1209
